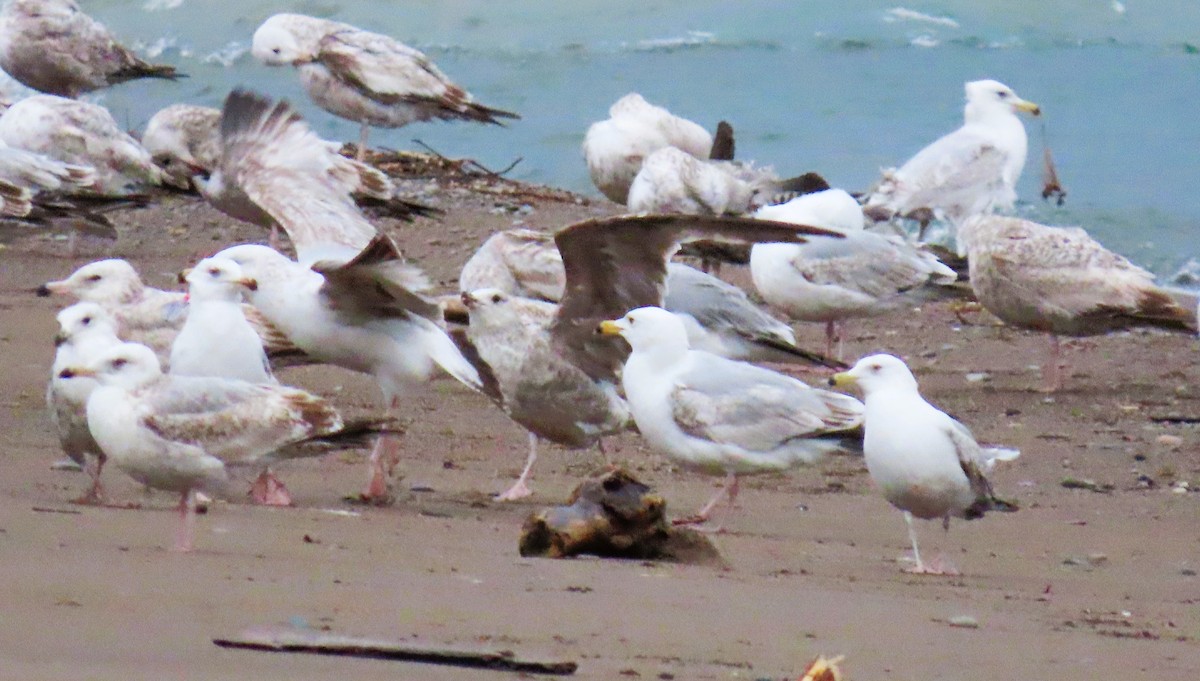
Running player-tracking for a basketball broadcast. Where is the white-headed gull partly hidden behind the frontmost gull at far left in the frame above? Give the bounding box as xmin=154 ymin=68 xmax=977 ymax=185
xmin=46 ymin=302 xmax=121 ymax=504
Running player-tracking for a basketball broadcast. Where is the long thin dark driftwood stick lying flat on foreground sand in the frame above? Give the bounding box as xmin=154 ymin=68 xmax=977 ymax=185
xmin=212 ymin=628 xmax=578 ymax=675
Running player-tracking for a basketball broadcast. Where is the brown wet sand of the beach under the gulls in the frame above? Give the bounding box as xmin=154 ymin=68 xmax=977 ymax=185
xmin=0 ymin=177 xmax=1200 ymax=681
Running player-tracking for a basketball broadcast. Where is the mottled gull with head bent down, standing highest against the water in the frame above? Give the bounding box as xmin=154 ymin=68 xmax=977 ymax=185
xmin=251 ymin=13 xmax=521 ymax=161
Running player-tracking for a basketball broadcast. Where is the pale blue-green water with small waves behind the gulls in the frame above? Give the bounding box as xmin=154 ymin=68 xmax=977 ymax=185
xmin=32 ymin=0 xmax=1200 ymax=276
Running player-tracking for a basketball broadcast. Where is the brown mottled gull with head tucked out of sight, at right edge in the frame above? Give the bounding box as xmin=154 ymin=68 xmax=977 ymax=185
xmin=959 ymin=216 xmax=1196 ymax=392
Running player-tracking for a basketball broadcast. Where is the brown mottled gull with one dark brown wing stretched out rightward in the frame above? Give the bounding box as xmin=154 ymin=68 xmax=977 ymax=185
xmin=463 ymin=216 xmax=844 ymax=499
